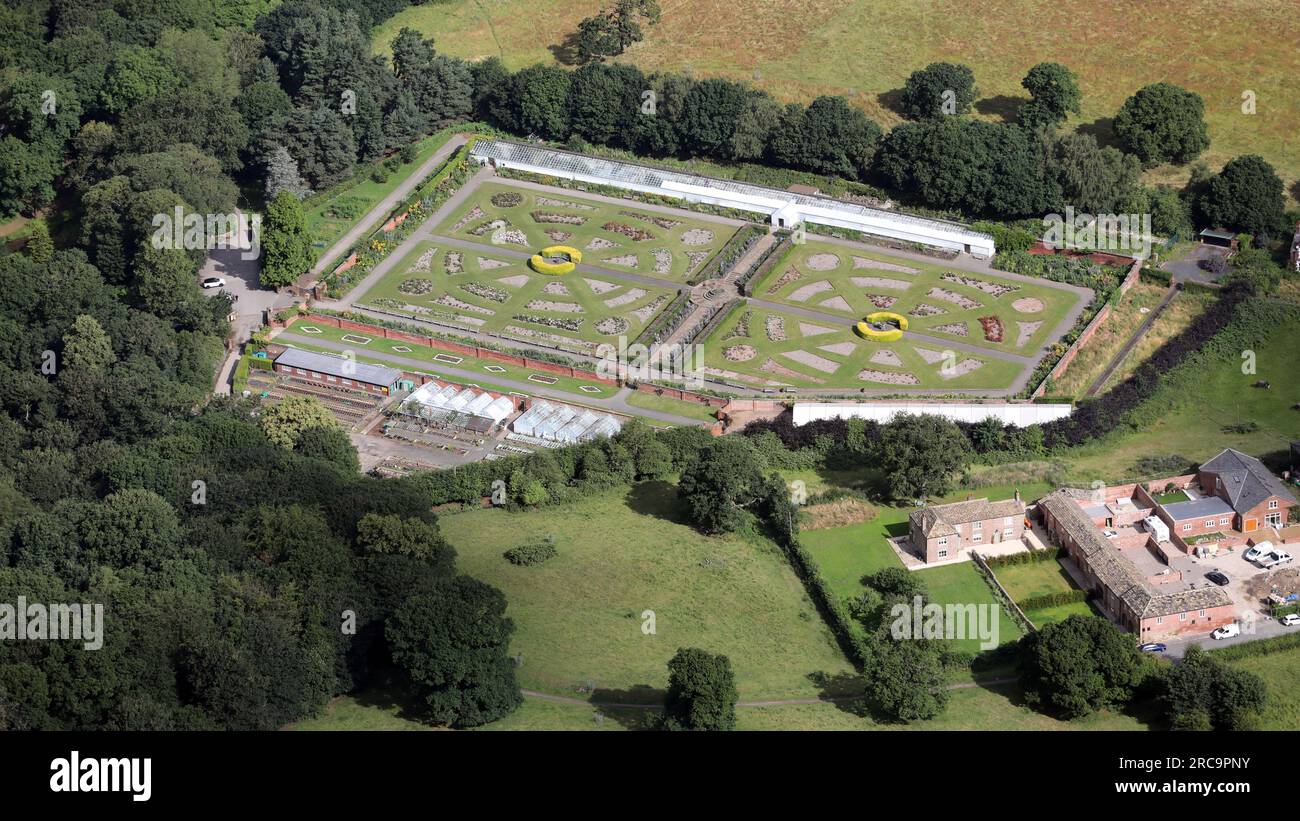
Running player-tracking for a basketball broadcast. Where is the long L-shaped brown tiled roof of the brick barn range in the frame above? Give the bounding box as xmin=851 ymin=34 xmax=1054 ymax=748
xmin=1039 ymin=490 xmax=1231 ymax=618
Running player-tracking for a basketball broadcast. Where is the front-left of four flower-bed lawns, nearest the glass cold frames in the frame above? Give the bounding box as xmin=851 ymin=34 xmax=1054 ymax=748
xmin=358 ymin=231 xmax=676 ymax=355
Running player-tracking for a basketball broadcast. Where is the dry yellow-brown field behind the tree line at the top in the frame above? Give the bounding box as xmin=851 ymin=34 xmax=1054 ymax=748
xmin=372 ymin=0 xmax=1300 ymax=198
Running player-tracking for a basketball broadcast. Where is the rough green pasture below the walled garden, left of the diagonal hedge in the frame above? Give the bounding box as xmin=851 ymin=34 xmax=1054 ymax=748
xmin=439 ymin=483 xmax=852 ymax=701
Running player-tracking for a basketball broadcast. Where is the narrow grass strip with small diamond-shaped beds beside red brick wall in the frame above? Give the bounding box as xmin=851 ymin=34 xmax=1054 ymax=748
xmin=278 ymin=320 xmax=618 ymax=399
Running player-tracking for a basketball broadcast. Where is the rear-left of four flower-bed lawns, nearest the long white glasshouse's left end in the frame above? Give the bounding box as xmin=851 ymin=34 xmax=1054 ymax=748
xmin=438 ymin=182 xmax=736 ymax=282
